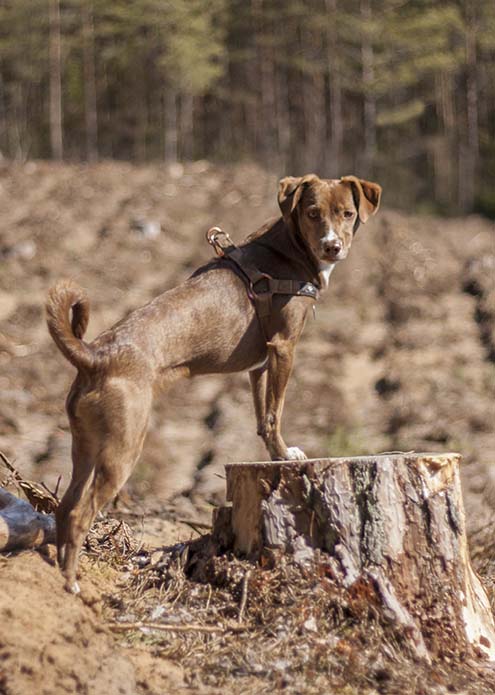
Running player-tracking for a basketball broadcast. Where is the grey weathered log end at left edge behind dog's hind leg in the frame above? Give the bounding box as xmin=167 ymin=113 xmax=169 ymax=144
xmin=0 ymin=488 xmax=55 ymax=552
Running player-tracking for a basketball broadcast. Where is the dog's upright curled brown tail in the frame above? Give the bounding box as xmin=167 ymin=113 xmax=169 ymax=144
xmin=46 ymin=280 xmax=96 ymax=369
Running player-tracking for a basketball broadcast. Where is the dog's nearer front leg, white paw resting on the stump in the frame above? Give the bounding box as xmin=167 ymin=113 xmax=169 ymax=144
xmin=262 ymin=339 xmax=306 ymax=460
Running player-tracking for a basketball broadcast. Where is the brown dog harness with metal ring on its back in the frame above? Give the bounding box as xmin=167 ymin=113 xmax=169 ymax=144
xmin=206 ymin=227 xmax=318 ymax=340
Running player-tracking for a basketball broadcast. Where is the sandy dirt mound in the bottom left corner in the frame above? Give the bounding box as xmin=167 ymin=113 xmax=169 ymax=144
xmin=0 ymin=552 xmax=183 ymax=695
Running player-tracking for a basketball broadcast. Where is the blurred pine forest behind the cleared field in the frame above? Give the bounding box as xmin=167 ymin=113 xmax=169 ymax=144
xmin=0 ymin=0 xmax=495 ymax=216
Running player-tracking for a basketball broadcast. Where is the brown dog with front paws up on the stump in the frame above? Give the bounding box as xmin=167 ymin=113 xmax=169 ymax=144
xmin=47 ymin=175 xmax=381 ymax=591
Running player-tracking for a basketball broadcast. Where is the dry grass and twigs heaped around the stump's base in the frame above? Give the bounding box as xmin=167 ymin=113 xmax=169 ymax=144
xmin=80 ymin=521 xmax=495 ymax=695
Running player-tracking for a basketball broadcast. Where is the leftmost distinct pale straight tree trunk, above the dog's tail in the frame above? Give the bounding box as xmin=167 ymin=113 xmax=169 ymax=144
xmin=49 ymin=0 xmax=64 ymax=159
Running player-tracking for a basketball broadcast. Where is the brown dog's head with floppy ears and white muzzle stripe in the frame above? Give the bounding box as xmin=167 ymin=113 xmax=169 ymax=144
xmin=278 ymin=174 xmax=382 ymax=265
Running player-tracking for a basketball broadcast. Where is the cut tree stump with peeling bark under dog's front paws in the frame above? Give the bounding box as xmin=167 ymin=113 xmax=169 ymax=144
xmin=213 ymin=453 xmax=495 ymax=660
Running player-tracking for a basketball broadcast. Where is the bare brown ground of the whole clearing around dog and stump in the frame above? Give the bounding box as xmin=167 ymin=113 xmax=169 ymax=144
xmin=0 ymin=162 xmax=495 ymax=695
